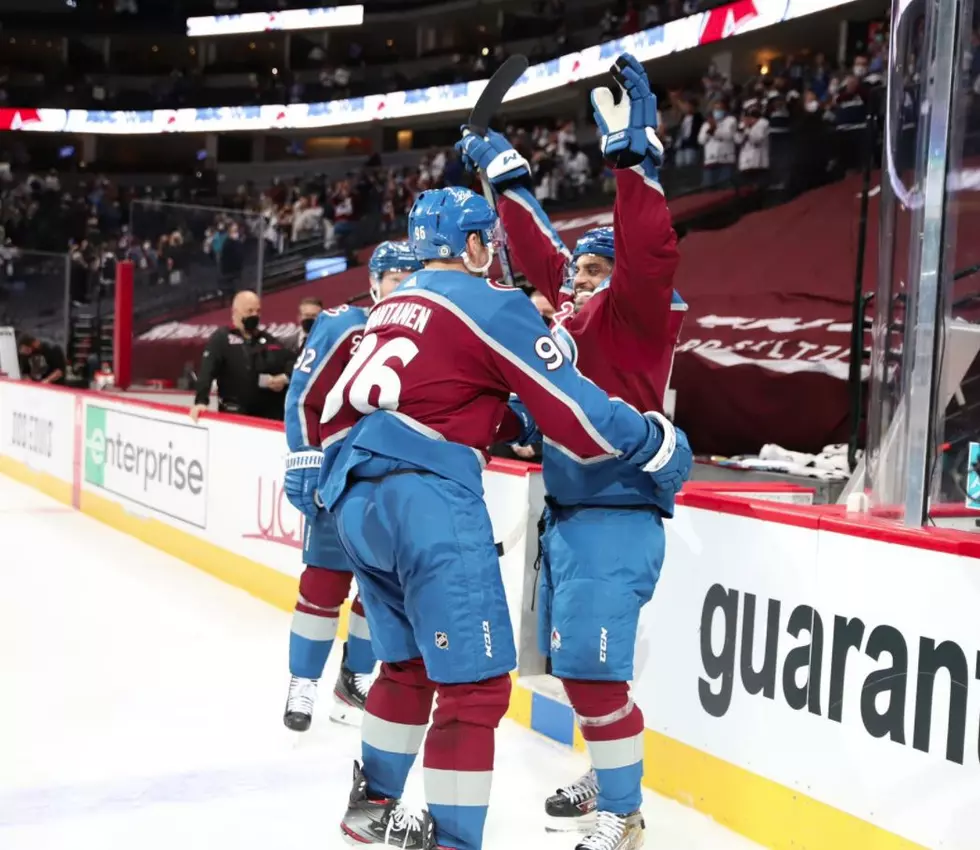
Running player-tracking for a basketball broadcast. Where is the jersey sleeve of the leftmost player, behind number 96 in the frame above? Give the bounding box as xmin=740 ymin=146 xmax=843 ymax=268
xmin=286 ymin=304 xmax=367 ymax=452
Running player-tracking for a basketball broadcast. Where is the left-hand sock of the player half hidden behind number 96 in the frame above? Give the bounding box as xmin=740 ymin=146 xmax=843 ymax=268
xmin=289 ymin=567 xmax=352 ymax=679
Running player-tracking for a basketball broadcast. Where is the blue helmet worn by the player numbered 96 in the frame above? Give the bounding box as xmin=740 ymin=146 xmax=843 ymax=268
xmin=408 ymin=186 xmax=497 ymax=274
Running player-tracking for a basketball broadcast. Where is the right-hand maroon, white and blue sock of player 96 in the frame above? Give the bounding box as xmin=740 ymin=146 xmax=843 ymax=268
xmin=425 ymin=676 xmax=510 ymax=850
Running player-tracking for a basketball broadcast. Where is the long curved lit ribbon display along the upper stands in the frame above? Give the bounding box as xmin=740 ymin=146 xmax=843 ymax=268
xmin=0 ymin=0 xmax=854 ymax=136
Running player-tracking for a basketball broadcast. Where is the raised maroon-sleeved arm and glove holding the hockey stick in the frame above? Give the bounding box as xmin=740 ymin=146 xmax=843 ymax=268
xmin=456 ymin=130 xmax=572 ymax=310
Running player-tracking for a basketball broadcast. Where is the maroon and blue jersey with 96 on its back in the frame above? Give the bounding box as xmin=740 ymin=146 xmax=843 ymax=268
xmin=319 ymin=271 xmax=672 ymax=509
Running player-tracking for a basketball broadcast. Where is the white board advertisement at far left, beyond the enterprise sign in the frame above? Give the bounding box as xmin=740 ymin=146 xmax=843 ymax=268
xmin=0 ymin=381 xmax=75 ymax=481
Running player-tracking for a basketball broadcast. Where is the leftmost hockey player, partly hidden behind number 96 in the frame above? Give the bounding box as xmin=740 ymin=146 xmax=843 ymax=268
xmin=283 ymin=242 xmax=421 ymax=732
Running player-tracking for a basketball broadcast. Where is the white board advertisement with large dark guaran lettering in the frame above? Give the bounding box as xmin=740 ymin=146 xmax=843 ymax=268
xmin=633 ymin=506 xmax=980 ymax=850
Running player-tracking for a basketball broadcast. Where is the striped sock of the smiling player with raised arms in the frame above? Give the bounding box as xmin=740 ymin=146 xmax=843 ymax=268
xmin=562 ymin=679 xmax=643 ymax=815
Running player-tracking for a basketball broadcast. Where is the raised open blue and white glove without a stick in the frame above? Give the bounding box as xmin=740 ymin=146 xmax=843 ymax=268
xmin=592 ymin=53 xmax=664 ymax=180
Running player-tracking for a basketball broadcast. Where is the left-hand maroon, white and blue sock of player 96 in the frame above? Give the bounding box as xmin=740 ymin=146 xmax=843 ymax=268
xmin=361 ymin=658 xmax=436 ymax=799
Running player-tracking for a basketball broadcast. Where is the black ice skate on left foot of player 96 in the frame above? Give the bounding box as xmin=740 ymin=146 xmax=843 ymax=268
xmin=340 ymin=761 xmax=437 ymax=850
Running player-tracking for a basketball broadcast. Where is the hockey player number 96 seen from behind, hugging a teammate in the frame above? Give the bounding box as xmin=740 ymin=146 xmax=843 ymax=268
xmin=318 ymin=188 xmax=691 ymax=850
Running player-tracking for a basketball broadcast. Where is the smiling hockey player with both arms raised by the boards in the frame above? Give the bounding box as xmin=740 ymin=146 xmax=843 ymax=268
xmin=459 ymin=54 xmax=685 ymax=850
